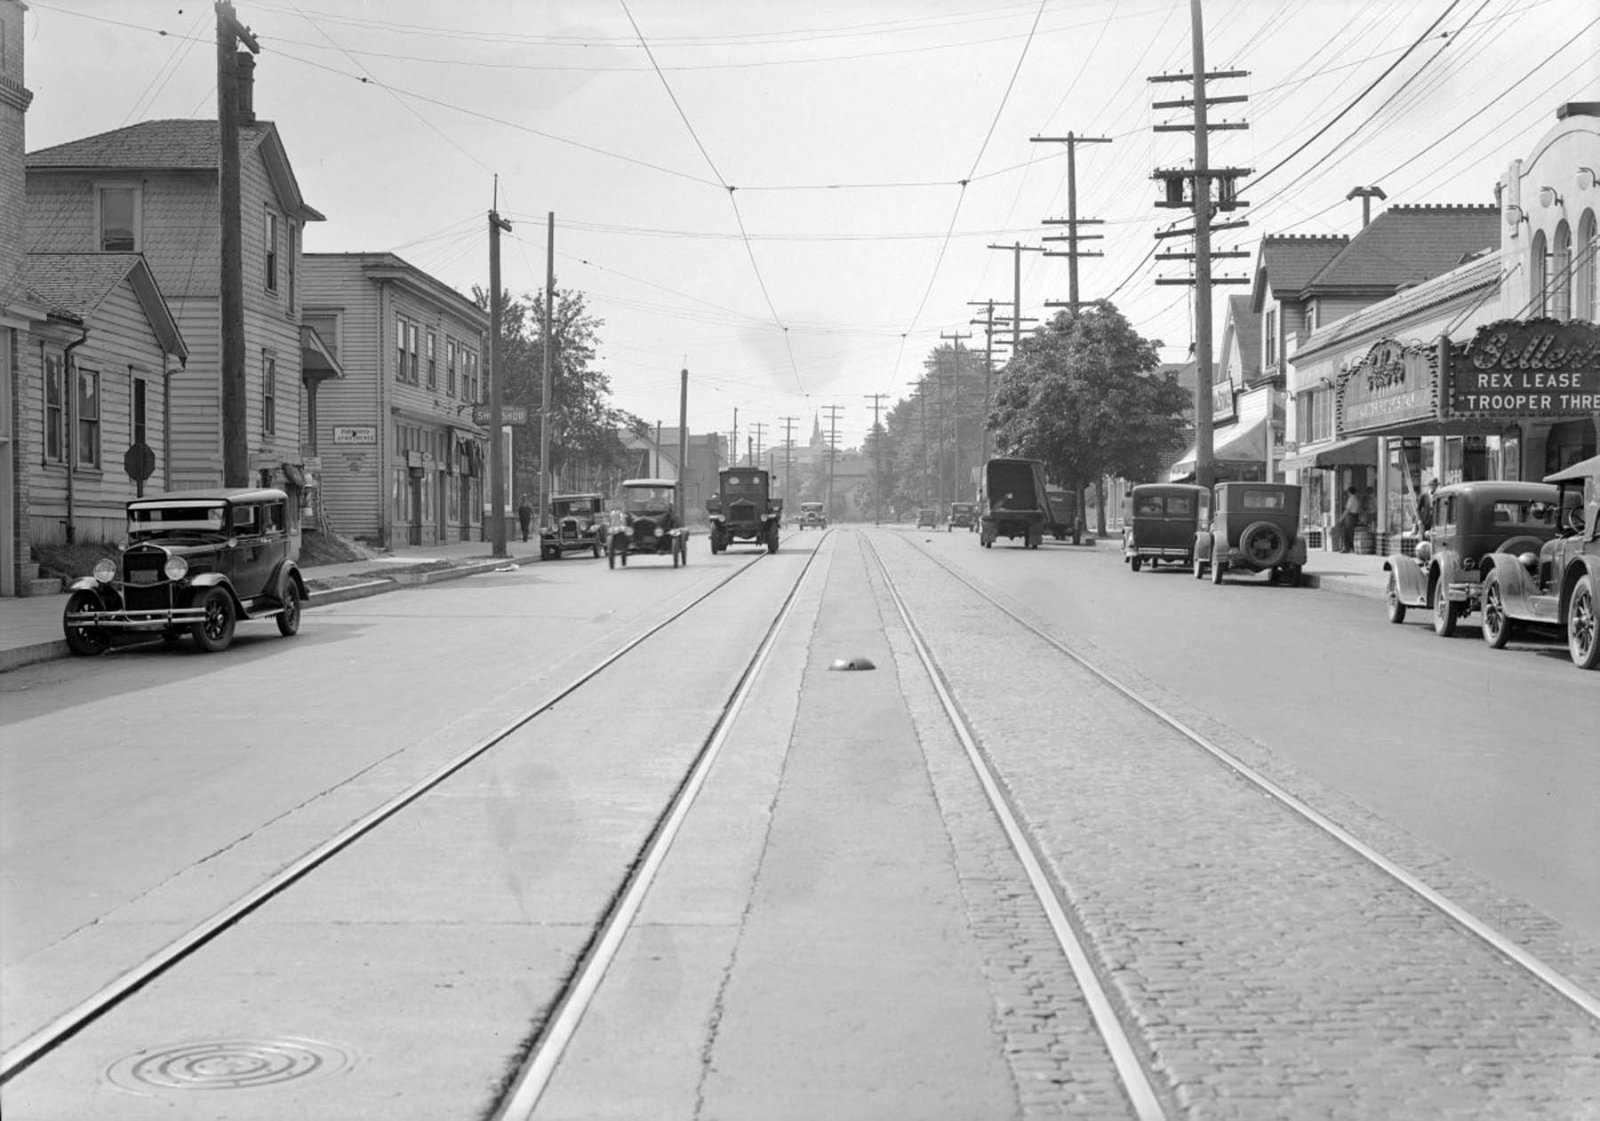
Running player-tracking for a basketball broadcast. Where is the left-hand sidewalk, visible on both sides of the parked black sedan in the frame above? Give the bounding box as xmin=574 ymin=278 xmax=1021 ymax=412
xmin=0 ymin=541 xmax=539 ymax=673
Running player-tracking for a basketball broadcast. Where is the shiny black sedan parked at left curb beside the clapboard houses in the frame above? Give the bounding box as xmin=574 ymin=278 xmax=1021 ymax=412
xmin=62 ymin=488 xmax=307 ymax=654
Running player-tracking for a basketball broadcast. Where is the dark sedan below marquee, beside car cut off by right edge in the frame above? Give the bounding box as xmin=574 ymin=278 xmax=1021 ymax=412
xmin=1384 ymin=480 xmax=1560 ymax=638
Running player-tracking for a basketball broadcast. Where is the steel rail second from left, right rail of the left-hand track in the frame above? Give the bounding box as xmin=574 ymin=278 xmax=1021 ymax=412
xmin=491 ymin=529 xmax=832 ymax=1121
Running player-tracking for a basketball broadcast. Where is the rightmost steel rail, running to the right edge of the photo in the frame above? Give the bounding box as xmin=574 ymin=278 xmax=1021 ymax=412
xmin=889 ymin=527 xmax=1600 ymax=1022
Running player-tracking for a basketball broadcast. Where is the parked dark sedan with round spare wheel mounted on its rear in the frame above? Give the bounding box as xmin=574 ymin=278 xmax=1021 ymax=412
xmin=1190 ymin=483 xmax=1306 ymax=587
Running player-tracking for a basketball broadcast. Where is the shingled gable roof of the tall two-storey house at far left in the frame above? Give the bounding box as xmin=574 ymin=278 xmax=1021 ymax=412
xmin=24 ymin=120 xmax=325 ymax=222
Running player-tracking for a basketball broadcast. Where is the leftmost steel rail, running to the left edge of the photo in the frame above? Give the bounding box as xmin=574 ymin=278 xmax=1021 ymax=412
xmin=0 ymin=534 xmax=800 ymax=1084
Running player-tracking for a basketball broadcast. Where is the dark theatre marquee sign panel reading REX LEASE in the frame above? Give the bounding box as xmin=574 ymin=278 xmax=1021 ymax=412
xmin=1450 ymin=320 xmax=1600 ymax=417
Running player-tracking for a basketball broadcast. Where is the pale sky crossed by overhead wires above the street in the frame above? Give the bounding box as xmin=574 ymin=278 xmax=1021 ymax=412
xmin=15 ymin=0 xmax=1600 ymax=448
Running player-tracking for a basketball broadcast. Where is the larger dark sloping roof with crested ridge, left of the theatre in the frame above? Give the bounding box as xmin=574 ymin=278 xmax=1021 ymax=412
xmin=1304 ymin=205 xmax=1501 ymax=296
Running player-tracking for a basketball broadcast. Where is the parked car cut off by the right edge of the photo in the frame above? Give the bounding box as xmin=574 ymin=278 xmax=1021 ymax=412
xmin=1480 ymin=456 xmax=1600 ymax=670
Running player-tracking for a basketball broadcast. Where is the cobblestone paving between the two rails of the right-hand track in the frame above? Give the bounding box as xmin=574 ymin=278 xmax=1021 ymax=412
xmin=870 ymin=530 xmax=1600 ymax=1121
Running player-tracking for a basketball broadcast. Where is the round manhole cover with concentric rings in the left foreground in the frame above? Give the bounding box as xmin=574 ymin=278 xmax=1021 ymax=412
xmin=106 ymin=1039 xmax=350 ymax=1092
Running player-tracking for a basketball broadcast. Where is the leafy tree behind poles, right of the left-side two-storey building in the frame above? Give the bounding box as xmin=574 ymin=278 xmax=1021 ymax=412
xmin=472 ymin=288 xmax=648 ymax=491
